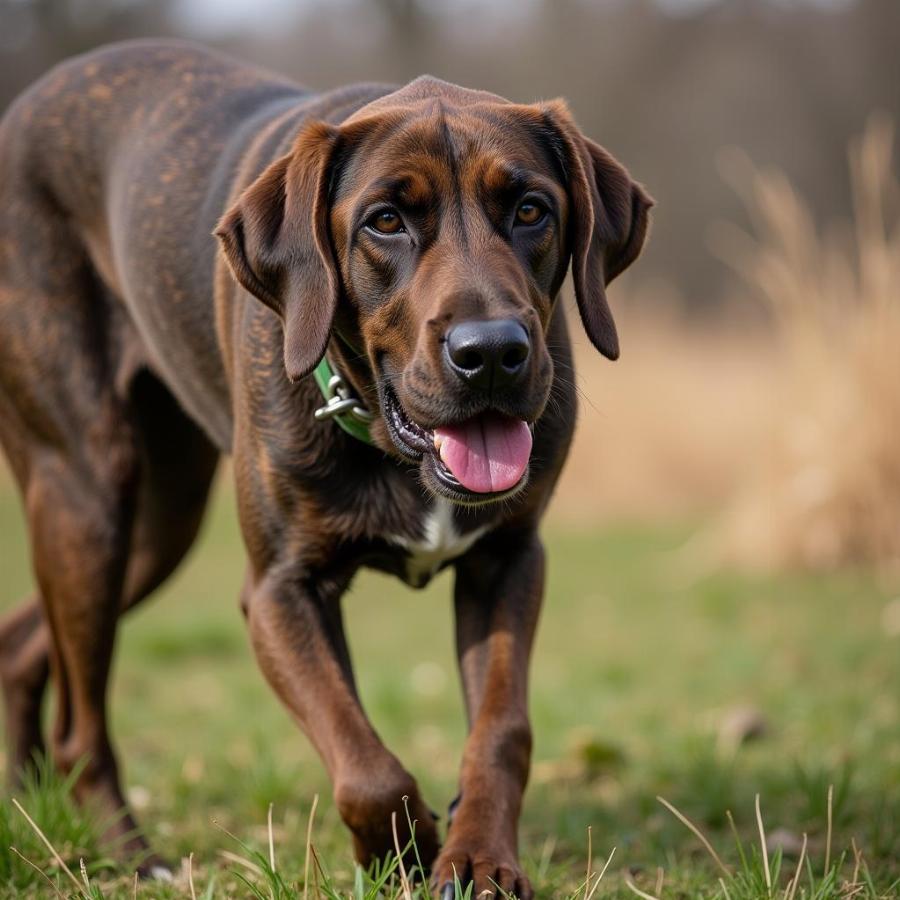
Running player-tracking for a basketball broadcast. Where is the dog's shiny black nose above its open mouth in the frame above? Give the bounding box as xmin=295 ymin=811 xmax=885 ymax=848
xmin=444 ymin=319 xmax=531 ymax=390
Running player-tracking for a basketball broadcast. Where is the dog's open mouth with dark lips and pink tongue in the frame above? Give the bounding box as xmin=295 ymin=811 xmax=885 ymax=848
xmin=383 ymin=388 xmax=532 ymax=499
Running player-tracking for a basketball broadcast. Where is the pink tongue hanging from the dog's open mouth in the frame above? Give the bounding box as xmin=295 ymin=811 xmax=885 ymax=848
xmin=434 ymin=413 xmax=531 ymax=494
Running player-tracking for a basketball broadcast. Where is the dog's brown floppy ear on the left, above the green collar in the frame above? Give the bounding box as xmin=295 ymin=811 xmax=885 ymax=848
xmin=215 ymin=123 xmax=340 ymax=381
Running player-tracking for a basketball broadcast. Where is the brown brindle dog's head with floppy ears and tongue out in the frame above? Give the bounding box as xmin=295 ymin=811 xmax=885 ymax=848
xmin=216 ymin=78 xmax=652 ymax=503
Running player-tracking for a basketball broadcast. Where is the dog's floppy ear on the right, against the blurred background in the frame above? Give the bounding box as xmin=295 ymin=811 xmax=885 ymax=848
xmin=545 ymin=101 xmax=653 ymax=359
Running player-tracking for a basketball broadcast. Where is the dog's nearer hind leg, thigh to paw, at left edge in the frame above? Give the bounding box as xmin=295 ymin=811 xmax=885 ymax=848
xmin=0 ymin=262 xmax=140 ymax=864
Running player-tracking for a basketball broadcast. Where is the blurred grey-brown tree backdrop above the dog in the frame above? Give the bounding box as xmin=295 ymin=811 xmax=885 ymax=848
xmin=0 ymin=0 xmax=900 ymax=311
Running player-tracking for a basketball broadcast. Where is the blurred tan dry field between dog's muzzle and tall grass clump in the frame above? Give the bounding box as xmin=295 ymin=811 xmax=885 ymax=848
xmin=551 ymin=304 xmax=777 ymax=526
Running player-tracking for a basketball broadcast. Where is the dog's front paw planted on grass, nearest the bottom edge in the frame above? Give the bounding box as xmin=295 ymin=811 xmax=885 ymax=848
xmin=431 ymin=844 xmax=534 ymax=900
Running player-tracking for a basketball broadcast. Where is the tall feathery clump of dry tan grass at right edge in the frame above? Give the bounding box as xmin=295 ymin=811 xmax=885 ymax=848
xmin=715 ymin=119 xmax=900 ymax=568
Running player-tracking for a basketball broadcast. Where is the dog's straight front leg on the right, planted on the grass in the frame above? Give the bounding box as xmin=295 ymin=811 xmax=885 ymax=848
xmin=434 ymin=532 xmax=544 ymax=900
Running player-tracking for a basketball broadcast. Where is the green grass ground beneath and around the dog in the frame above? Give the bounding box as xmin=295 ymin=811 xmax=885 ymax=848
xmin=0 ymin=478 xmax=900 ymax=900
